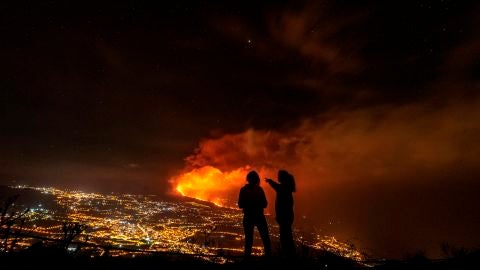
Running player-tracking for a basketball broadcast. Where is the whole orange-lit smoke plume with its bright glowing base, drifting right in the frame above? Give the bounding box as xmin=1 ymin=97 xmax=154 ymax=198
xmin=170 ymin=96 xmax=480 ymax=228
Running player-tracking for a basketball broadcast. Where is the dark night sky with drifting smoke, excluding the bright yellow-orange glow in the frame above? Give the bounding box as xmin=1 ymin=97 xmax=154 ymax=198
xmin=0 ymin=0 xmax=480 ymax=257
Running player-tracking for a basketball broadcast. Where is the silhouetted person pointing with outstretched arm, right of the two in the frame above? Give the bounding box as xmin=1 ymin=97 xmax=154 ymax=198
xmin=265 ymin=170 xmax=295 ymax=257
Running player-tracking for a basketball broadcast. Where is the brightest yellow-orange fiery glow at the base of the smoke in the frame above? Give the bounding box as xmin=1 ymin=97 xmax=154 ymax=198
xmin=171 ymin=166 xmax=250 ymax=207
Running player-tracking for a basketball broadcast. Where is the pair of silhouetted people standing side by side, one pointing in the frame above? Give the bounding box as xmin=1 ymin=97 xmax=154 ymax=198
xmin=238 ymin=170 xmax=295 ymax=257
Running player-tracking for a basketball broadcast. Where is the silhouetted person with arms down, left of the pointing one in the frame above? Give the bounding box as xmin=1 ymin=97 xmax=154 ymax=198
xmin=238 ymin=171 xmax=271 ymax=257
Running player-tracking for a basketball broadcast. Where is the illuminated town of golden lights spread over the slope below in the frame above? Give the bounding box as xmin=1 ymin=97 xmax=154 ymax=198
xmin=2 ymin=186 xmax=364 ymax=262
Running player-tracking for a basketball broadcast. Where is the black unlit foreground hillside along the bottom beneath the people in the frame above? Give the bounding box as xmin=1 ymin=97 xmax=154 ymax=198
xmin=0 ymin=248 xmax=480 ymax=270
